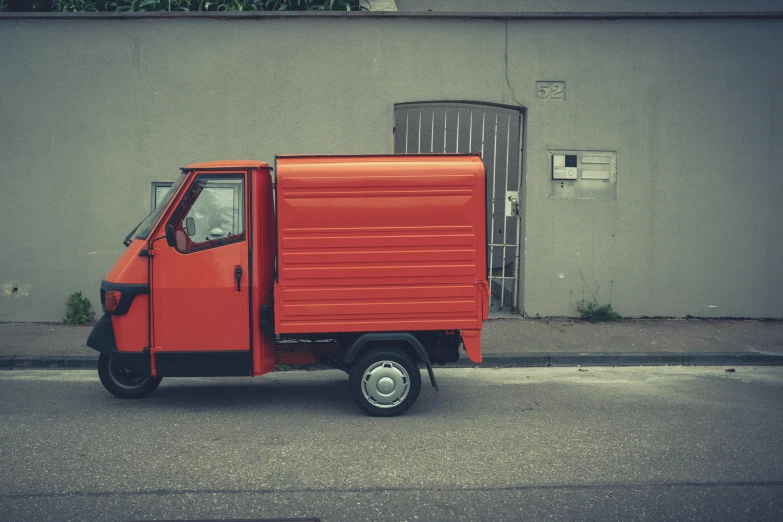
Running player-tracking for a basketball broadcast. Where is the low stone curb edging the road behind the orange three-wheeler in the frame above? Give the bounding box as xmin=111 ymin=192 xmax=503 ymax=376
xmin=0 ymin=352 xmax=783 ymax=370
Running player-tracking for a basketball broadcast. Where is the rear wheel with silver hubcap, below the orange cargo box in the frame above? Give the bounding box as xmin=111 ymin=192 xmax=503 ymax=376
xmin=348 ymin=348 xmax=421 ymax=417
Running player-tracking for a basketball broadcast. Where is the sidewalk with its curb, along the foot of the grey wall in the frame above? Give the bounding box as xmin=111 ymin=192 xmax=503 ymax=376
xmin=0 ymin=317 xmax=783 ymax=369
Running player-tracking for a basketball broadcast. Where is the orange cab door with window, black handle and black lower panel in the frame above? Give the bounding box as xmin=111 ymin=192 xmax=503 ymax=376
xmin=150 ymin=171 xmax=251 ymax=377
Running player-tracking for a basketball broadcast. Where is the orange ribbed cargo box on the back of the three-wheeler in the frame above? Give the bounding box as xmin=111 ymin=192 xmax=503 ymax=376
xmin=275 ymin=154 xmax=488 ymax=334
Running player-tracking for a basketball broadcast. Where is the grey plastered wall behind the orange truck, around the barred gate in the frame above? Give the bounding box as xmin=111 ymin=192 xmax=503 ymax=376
xmin=0 ymin=16 xmax=783 ymax=321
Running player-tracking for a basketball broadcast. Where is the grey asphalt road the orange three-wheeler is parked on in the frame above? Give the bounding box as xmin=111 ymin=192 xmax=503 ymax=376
xmin=0 ymin=367 xmax=783 ymax=521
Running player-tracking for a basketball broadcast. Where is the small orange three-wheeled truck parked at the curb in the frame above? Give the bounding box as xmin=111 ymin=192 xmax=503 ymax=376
xmin=87 ymin=154 xmax=489 ymax=416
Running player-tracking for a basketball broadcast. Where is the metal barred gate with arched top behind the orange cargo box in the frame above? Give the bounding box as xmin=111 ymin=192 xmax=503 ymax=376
xmin=394 ymin=103 xmax=524 ymax=312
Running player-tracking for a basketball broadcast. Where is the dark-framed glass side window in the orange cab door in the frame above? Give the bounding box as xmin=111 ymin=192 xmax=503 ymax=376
xmin=174 ymin=176 xmax=245 ymax=253
